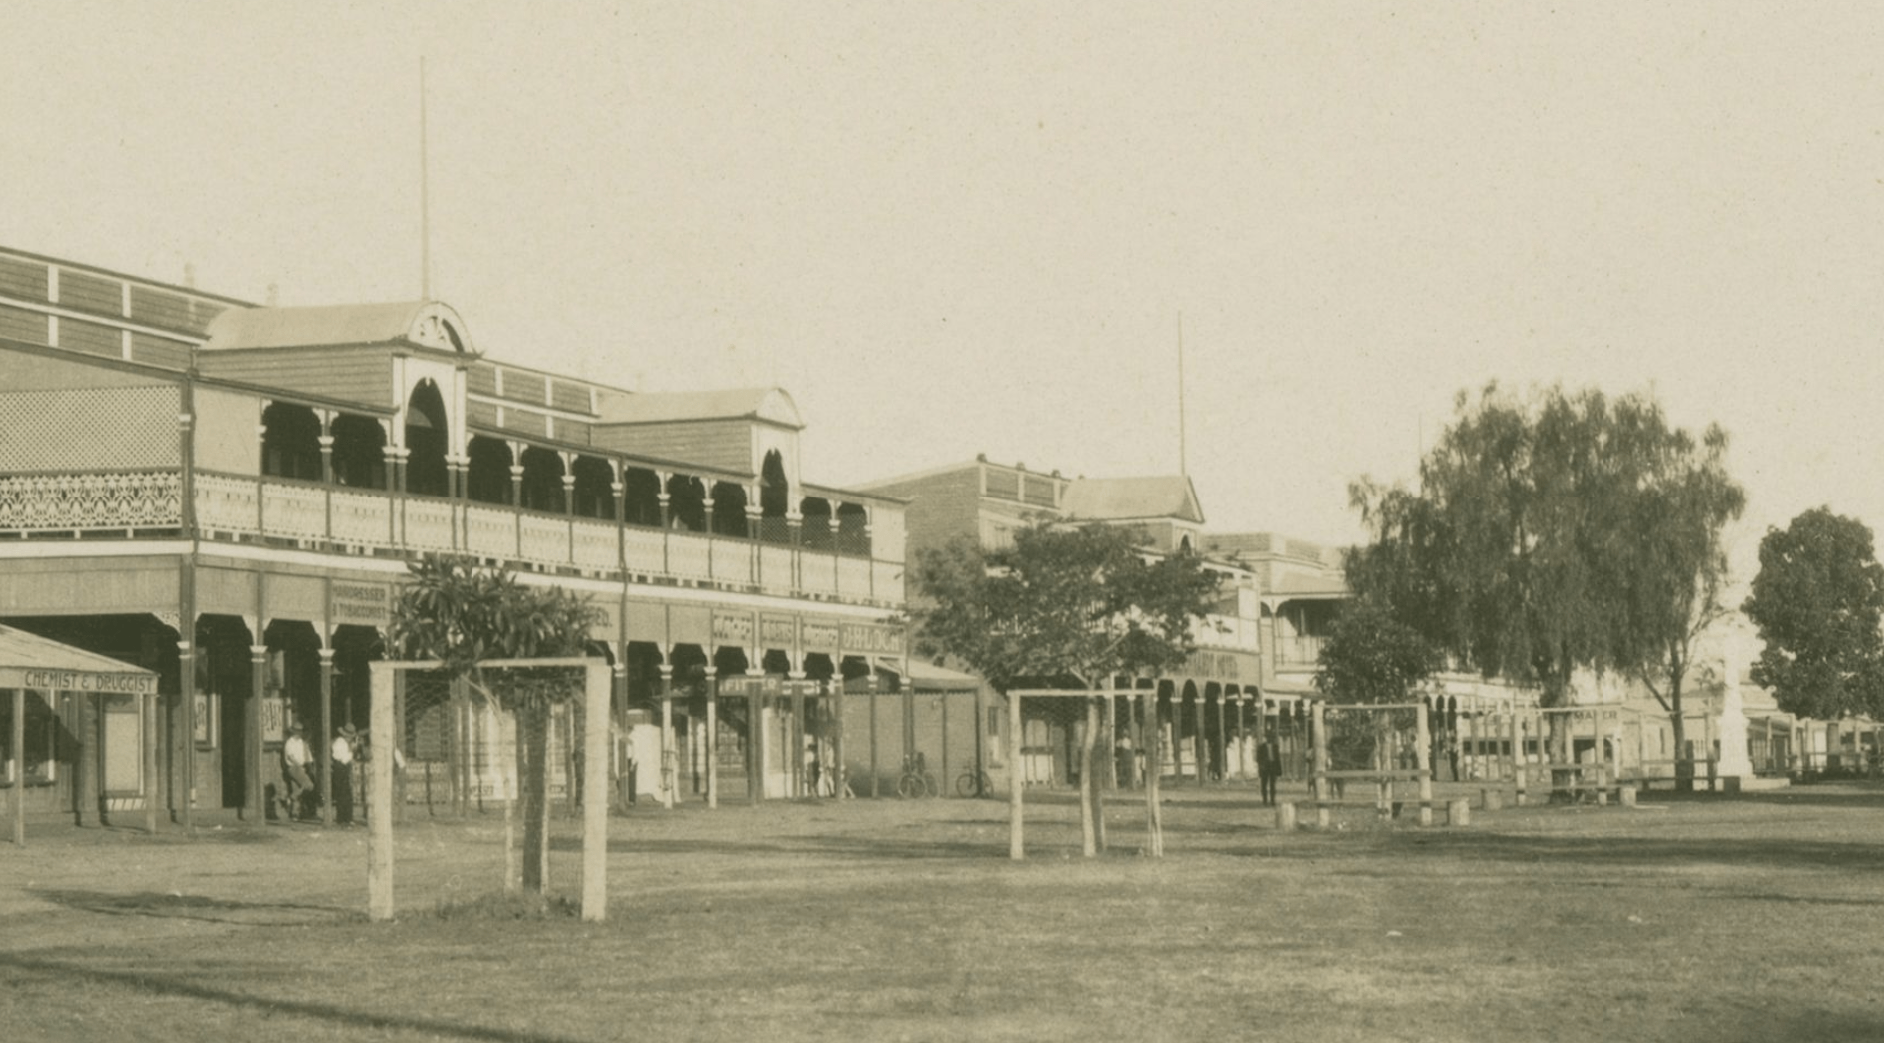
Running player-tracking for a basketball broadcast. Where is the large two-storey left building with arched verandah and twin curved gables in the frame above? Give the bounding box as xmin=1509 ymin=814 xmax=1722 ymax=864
xmin=0 ymin=249 xmax=906 ymax=821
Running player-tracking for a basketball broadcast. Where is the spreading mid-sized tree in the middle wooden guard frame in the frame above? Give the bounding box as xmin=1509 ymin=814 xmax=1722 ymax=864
xmin=916 ymin=522 xmax=1219 ymax=858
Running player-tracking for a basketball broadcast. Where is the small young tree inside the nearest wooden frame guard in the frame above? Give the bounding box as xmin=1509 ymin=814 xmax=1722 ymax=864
xmin=388 ymin=555 xmax=605 ymax=894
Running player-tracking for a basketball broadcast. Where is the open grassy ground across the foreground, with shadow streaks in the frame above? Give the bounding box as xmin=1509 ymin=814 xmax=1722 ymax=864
xmin=0 ymin=785 xmax=1884 ymax=1043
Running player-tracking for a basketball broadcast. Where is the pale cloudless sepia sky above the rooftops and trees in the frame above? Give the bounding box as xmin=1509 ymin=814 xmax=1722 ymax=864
xmin=0 ymin=0 xmax=1884 ymax=582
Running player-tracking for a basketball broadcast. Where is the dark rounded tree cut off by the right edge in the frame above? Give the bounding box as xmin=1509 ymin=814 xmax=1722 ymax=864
xmin=1743 ymin=506 xmax=1884 ymax=719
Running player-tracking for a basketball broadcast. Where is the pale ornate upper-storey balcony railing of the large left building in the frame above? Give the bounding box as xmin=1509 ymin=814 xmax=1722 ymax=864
xmin=0 ymin=471 xmax=904 ymax=602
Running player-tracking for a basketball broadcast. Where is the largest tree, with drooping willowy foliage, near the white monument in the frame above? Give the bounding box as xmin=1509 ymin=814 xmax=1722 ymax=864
xmin=1349 ymin=384 xmax=1745 ymax=786
